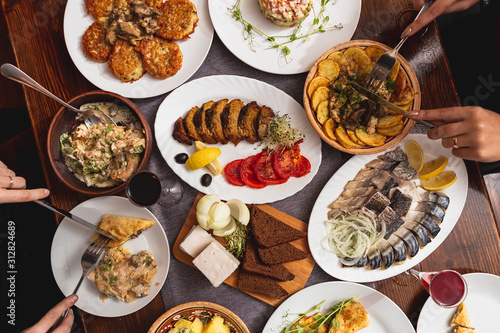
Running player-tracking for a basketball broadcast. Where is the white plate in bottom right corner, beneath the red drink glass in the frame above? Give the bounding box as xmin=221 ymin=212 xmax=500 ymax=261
xmin=417 ymin=273 xmax=500 ymax=333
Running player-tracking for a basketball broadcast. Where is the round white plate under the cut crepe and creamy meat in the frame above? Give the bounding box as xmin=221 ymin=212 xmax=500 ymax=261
xmin=50 ymin=197 xmax=170 ymax=317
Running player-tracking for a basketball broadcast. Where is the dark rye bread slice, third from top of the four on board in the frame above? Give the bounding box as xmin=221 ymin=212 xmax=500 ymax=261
xmin=243 ymin=239 xmax=295 ymax=281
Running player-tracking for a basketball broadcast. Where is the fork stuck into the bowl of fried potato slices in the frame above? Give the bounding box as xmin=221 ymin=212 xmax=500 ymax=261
xmin=365 ymin=0 xmax=435 ymax=91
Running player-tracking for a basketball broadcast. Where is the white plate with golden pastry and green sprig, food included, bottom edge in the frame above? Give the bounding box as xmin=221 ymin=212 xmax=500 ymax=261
xmin=263 ymin=281 xmax=415 ymax=333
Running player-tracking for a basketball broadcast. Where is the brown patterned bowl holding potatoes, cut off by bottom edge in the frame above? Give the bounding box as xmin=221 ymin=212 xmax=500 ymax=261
xmin=148 ymin=302 xmax=250 ymax=333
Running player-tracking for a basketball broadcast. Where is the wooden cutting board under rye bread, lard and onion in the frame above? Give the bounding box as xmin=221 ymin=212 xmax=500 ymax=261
xmin=173 ymin=193 xmax=315 ymax=306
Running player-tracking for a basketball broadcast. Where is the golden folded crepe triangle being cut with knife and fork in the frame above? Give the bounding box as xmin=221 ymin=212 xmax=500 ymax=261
xmin=91 ymin=214 xmax=155 ymax=247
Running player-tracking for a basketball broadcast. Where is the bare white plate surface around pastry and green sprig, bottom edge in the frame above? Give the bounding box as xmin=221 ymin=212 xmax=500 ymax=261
xmin=262 ymin=281 xmax=415 ymax=333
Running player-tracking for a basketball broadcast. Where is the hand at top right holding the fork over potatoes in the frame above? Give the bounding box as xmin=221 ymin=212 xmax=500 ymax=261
xmin=401 ymin=0 xmax=479 ymax=38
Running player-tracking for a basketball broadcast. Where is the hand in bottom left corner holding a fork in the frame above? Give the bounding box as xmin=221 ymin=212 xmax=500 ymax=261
xmin=23 ymin=294 xmax=78 ymax=333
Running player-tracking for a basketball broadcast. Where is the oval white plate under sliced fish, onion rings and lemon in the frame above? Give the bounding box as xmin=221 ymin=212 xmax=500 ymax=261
xmin=308 ymin=134 xmax=469 ymax=282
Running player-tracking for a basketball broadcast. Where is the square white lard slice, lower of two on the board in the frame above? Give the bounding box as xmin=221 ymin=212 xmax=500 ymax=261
xmin=193 ymin=241 xmax=240 ymax=287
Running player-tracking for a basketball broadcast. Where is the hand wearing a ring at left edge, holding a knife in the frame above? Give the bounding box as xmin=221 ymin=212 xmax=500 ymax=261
xmin=0 ymin=161 xmax=49 ymax=204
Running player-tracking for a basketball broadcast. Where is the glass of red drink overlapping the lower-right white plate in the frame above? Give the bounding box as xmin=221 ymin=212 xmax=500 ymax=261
xmin=408 ymin=268 xmax=468 ymax=308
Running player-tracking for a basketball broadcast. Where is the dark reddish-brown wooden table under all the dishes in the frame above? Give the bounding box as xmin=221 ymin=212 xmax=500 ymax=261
xmin=2 ymin=0 xmax=500 ymax=332
